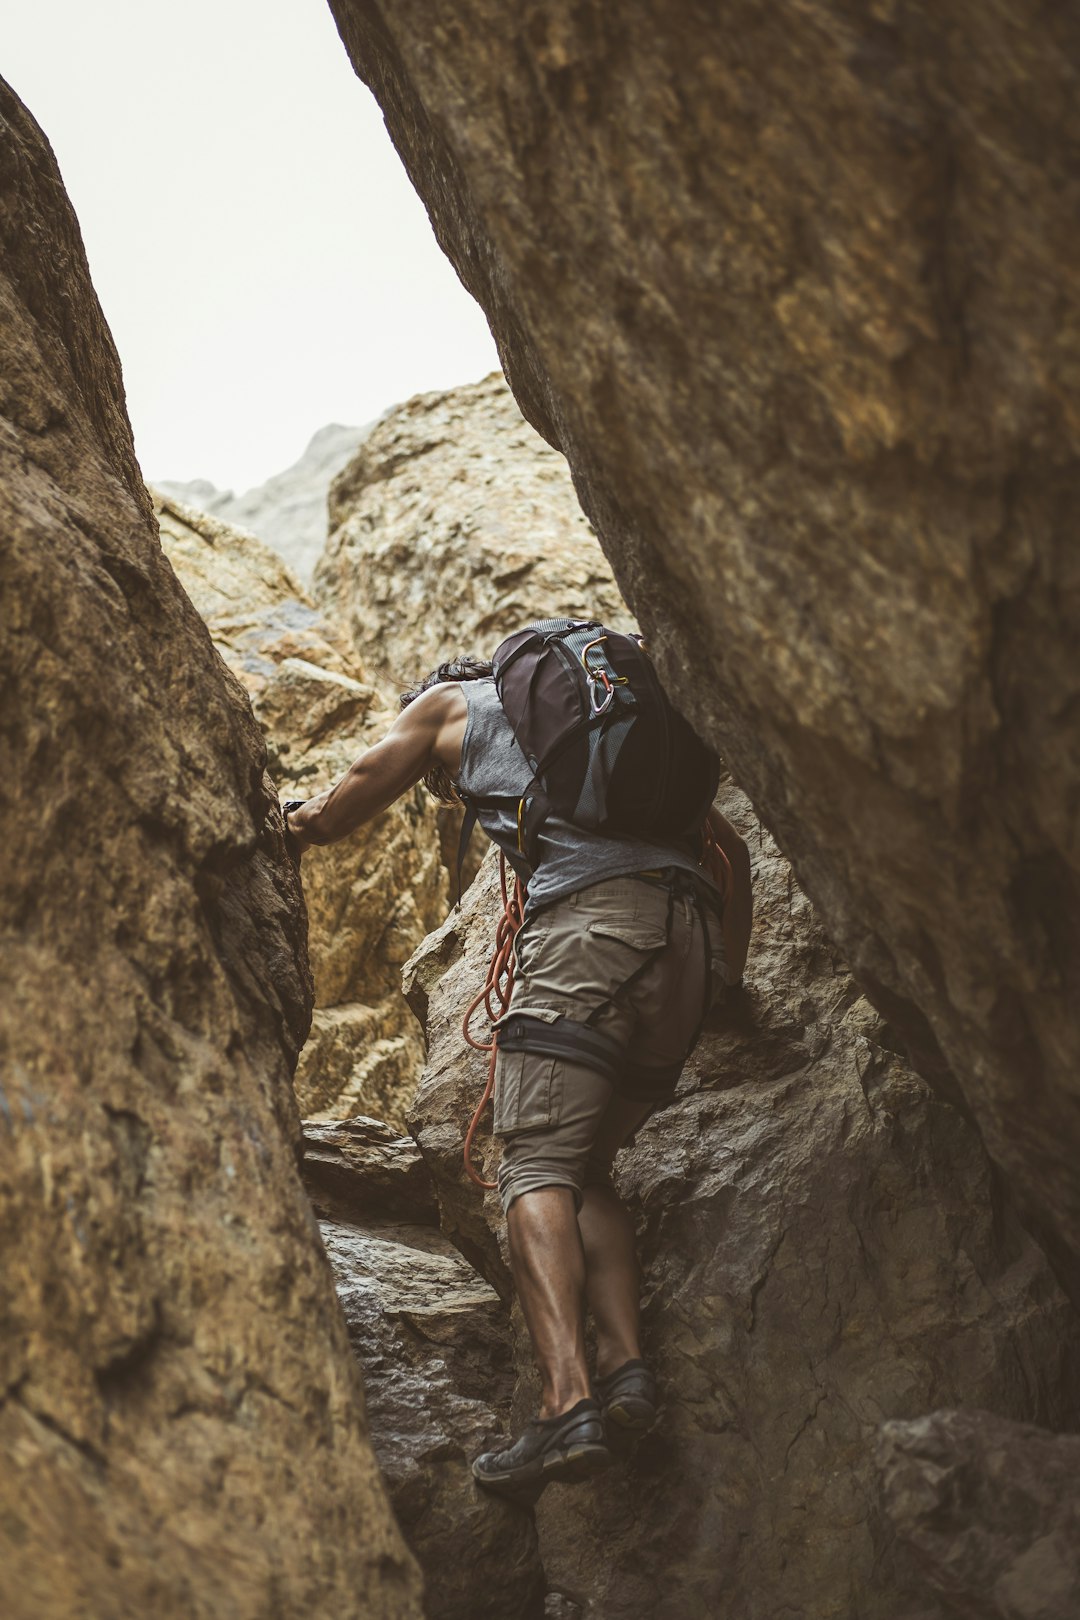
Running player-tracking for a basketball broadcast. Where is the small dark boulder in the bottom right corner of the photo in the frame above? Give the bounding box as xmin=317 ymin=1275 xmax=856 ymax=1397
xmin=878 ymin=1411 xmax=1080 ymax=1620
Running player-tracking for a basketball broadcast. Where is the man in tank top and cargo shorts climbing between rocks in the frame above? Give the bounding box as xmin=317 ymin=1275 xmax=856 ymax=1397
xmin=287 ymin=620 xmax=751 ymax=1500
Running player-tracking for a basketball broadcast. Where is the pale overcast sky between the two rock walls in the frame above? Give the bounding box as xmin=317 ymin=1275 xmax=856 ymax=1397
xmin=0 ymin=0 xmax=499 ymax=491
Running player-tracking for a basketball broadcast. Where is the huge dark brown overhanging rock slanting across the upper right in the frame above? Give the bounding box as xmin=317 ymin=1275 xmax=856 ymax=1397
xmin=332 ymin=0 xmax=1080 ymax=1286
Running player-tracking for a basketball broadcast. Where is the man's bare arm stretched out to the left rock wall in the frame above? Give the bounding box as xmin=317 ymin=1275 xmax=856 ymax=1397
xmin=288 ymin=687 xmax=460 ymax=849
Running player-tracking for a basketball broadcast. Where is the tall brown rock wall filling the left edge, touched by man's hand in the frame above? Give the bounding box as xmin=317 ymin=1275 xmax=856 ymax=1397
xmin=0 ymin=83 xmax=419 ymax=1620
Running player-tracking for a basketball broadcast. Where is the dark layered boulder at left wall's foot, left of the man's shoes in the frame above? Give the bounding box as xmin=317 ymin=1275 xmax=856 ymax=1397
xmin=304 ymin=1119 xmax=544 ymax=1620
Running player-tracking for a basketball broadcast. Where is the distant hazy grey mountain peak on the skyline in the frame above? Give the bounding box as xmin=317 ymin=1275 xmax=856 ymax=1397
xmin=157 ymin=423 xmax=372 ymax=585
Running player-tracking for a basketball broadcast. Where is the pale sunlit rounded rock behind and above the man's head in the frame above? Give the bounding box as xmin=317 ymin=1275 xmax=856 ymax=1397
xmin=314 ymin=374 xmax=631 ymax=692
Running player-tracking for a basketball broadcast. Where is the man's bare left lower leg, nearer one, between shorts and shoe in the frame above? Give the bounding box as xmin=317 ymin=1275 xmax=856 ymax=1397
xmin=507 ymin=1187 xmax=591 ymax=1418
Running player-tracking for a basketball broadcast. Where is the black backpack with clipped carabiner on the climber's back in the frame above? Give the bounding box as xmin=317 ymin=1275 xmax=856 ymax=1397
xmin=482 ymin=619 xmax=721 ymax=870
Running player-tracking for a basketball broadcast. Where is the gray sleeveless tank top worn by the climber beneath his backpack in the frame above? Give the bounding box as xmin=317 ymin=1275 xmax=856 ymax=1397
xmin=458 ymin=679 xmax=716 ymax=912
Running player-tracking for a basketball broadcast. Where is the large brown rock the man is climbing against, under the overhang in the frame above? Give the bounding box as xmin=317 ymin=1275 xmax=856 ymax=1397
xmin=406 ymin=803 xmax=1080 ymax=1620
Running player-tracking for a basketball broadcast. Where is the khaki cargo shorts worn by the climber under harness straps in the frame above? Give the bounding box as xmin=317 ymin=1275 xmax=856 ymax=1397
xmin=495 ymin=868 xmax=724 ymax=1210
